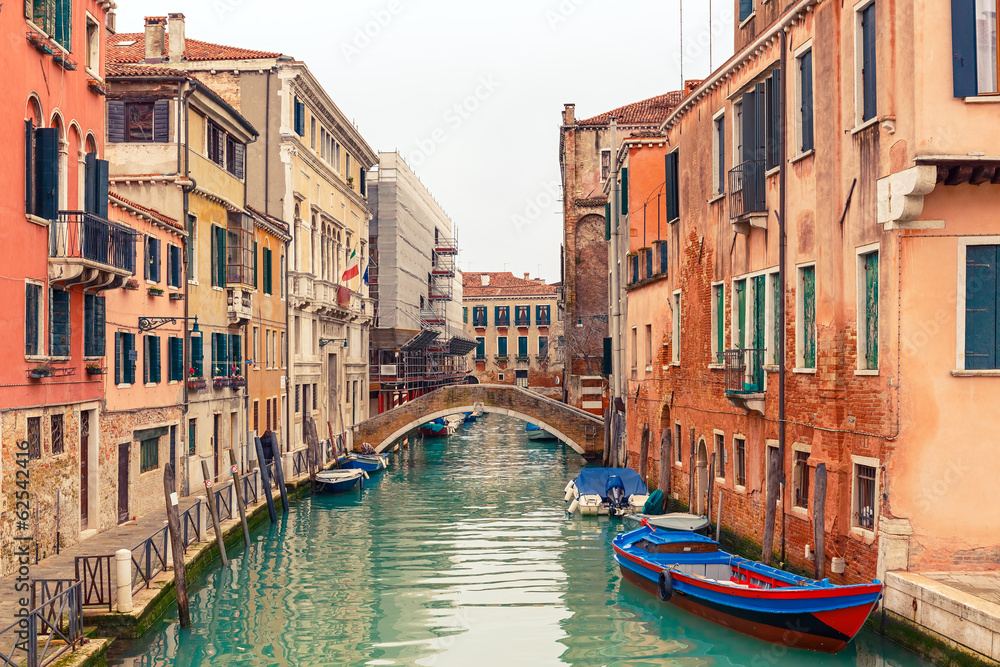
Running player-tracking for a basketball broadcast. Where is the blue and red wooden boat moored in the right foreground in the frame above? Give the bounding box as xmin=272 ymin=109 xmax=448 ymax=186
xmin=612 ymin=526 xmax=882 ymax=653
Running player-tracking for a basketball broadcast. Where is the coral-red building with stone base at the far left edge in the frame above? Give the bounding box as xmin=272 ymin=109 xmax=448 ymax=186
xmin=0 ymin=0 xmax=120 ymax=574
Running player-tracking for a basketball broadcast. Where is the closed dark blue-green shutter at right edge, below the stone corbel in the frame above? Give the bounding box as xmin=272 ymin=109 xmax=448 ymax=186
xmin=965 ymin=245 xmax=1000 ymax=370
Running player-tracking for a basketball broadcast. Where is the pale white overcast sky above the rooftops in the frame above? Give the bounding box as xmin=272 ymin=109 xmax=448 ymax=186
xmin=117 ymin=0 xmax=733 ymax=282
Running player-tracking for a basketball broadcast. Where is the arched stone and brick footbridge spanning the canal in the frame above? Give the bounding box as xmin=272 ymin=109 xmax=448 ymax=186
xmin=354 ymin=384 xmax=604 ymax=458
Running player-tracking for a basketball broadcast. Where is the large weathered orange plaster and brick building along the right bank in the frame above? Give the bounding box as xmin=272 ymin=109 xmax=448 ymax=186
xmin=617 ymin=0 xmax=1000 ymax=600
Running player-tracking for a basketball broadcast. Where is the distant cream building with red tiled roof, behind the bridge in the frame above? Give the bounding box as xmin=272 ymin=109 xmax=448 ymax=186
xmin=462 ymin=271 xmax=565 ymax=400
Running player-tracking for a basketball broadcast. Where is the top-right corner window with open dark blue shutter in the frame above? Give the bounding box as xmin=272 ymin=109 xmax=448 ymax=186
xmin=951 ymin=0 xmax=1000 ymax=97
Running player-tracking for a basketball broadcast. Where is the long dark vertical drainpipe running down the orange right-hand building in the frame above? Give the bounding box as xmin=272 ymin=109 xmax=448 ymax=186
xmin=778 ymin=30 xmax=788 ymax=563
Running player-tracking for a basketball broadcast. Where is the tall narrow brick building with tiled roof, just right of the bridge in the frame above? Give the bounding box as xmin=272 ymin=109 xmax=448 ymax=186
xmin=559 ymin=93 xmax=680 ymax=415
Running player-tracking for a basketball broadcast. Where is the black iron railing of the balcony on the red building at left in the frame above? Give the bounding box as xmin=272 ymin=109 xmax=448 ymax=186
xmin=49 ymin=211 xmax=136 ymax=273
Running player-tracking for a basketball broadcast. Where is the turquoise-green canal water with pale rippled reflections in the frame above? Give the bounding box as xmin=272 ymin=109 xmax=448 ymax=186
xmin=109 ymin=415 xmax=926 ymax=667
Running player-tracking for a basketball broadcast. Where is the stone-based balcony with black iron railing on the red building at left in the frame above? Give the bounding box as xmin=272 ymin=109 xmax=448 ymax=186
xmin=49 ymin=211 xmax=136 ymax=291
